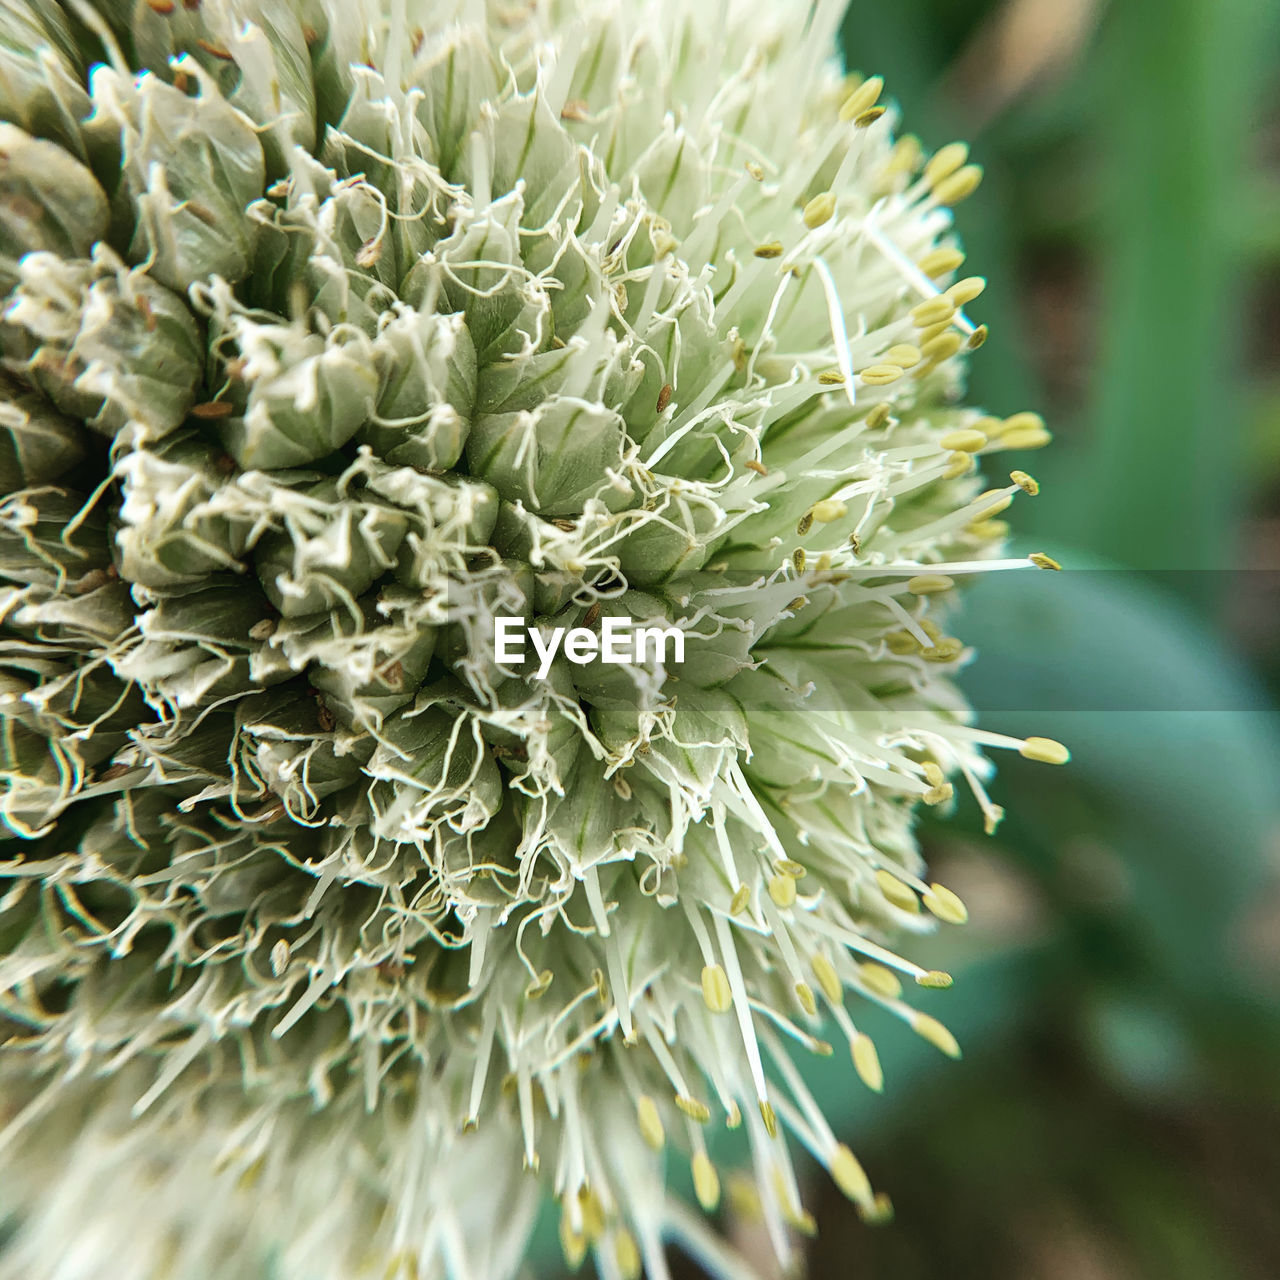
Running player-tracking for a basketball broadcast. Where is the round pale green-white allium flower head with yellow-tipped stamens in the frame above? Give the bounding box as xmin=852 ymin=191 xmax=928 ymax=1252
xmin=0 ymin=0 xmax=1065 ymax=1280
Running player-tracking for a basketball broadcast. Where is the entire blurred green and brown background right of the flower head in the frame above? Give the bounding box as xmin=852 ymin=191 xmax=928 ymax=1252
xmin=660 ymin=0 xmax=1280 ymax=1280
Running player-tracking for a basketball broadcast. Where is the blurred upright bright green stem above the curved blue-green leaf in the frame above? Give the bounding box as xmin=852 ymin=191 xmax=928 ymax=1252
xmin=1080 ymin=0 xmax=1268 ymax=612
